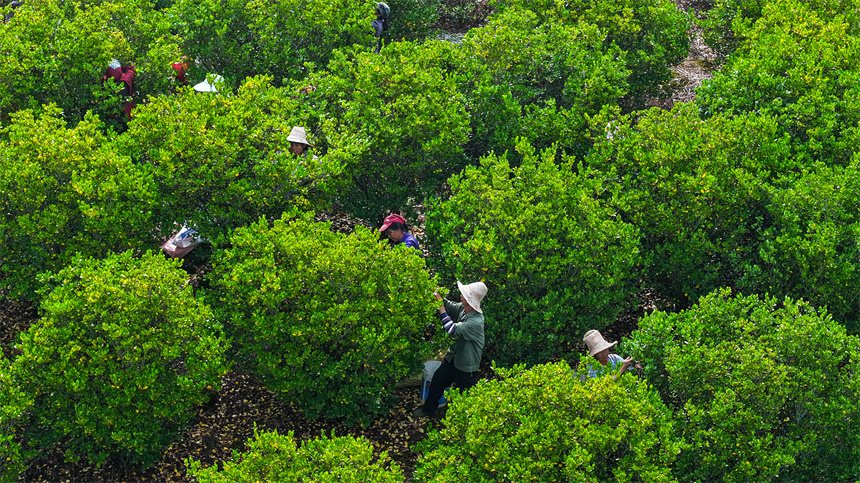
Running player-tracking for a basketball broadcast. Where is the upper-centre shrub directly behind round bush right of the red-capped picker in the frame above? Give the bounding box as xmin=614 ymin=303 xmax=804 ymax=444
xmin=453 ymin=10 xmax=629 ymax=158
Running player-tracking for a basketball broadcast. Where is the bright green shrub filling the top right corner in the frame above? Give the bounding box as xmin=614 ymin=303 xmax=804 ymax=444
xmin=697 ymin=0 xmax=860 ymax=166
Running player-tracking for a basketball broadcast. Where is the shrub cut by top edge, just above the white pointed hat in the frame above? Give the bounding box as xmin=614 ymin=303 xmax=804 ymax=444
xmin=165 ymin=0 xmax=376 ymax=86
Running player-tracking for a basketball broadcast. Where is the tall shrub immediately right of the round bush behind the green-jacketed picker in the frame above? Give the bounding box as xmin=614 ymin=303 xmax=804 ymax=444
xmin=586 ymin=106 xmax=796 ymax=307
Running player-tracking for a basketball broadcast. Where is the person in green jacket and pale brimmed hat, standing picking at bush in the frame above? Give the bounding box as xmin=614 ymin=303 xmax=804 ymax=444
xmin=412 ymin=281 xmax=487 ymax=418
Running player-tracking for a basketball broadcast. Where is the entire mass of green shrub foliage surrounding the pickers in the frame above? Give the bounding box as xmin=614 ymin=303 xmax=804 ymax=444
xmin=0 ymin=0 xmax=860 ymax=481
